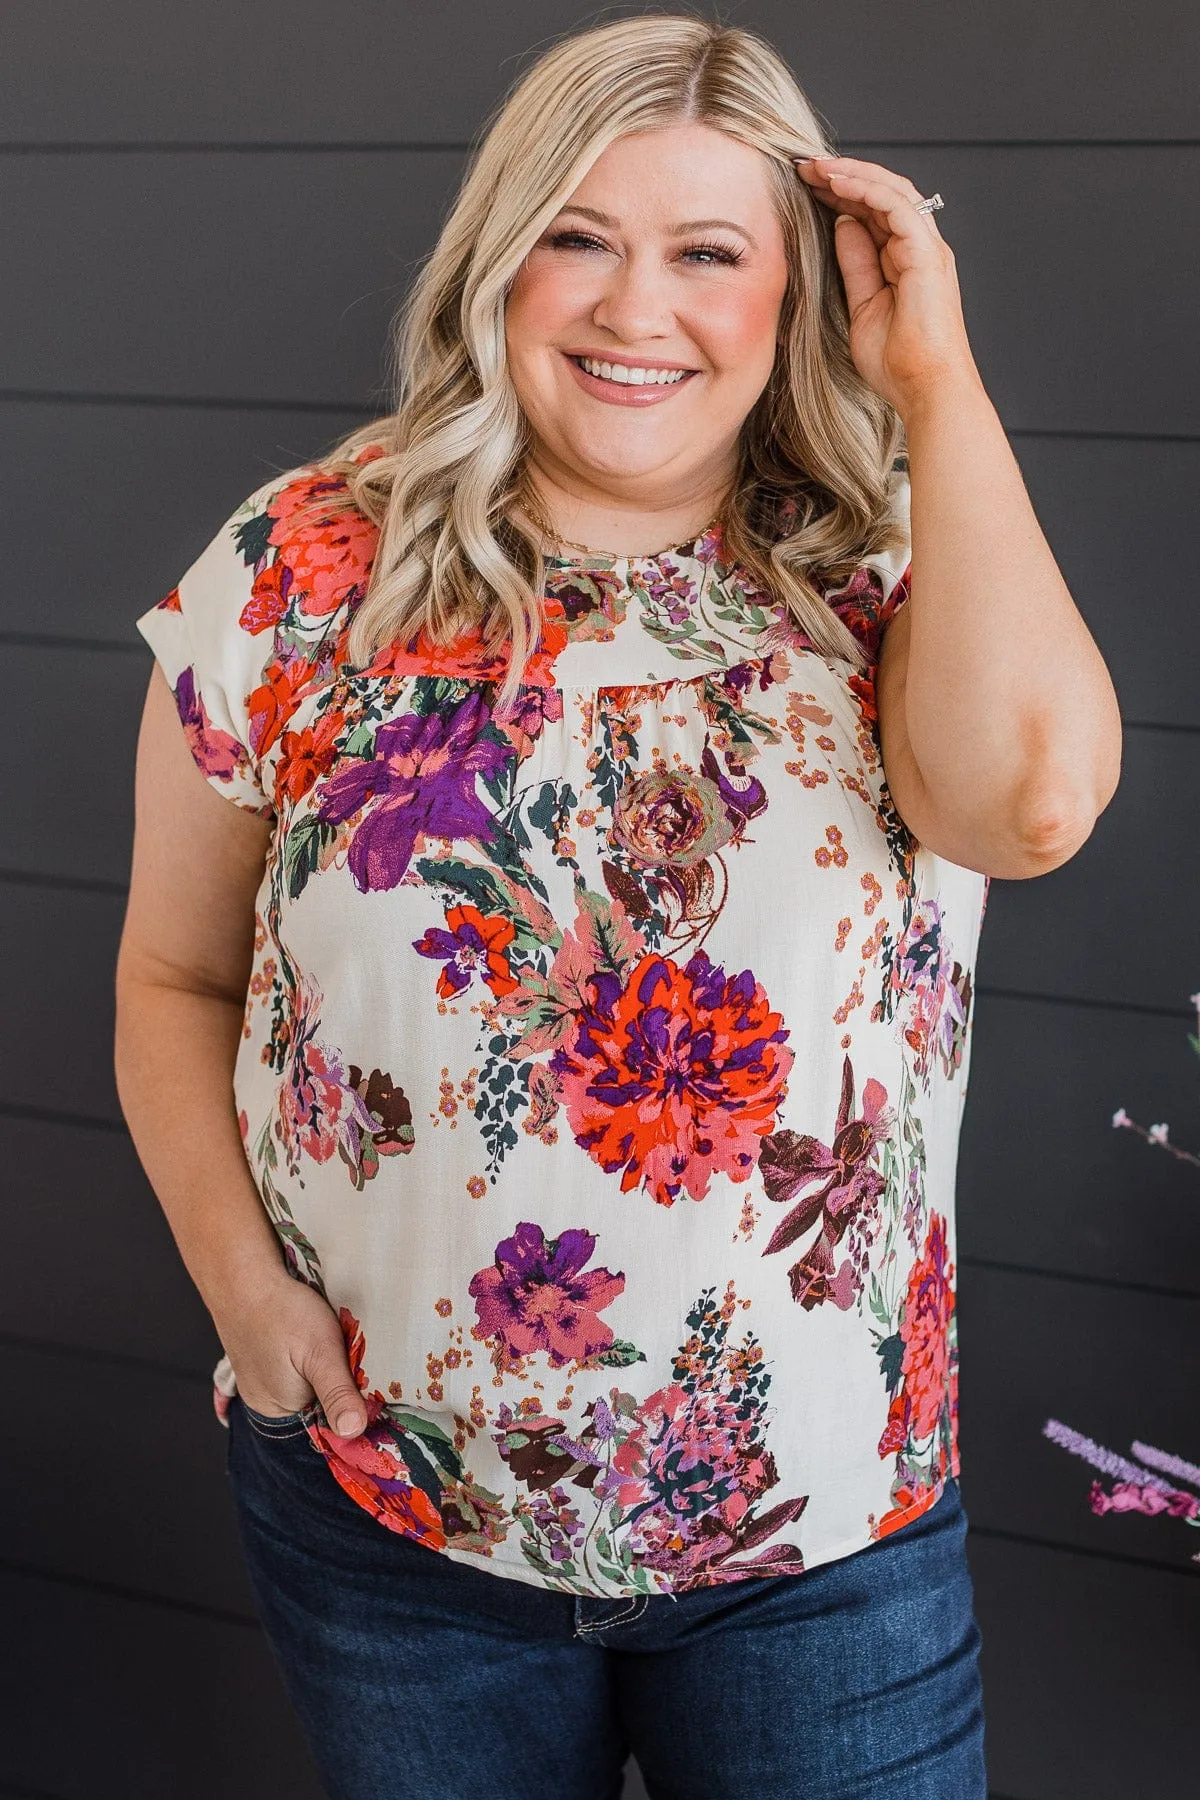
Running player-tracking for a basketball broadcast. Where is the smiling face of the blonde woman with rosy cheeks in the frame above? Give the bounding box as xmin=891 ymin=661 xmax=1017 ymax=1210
xmin=506 ymin=124 xmax=788 ymax=513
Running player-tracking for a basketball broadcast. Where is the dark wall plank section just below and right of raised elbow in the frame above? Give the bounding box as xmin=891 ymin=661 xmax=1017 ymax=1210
xmin=977 ymin=731 xmax=1200 ymax=1015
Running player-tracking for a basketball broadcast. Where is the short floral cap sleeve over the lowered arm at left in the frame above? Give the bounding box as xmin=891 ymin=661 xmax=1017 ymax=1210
xmin=135 ymin=473 xmax=291 ymax=819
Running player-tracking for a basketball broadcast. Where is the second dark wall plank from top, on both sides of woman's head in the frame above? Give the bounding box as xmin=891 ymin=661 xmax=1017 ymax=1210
xmin=0 ymin=149 xmax=1200 ymax=436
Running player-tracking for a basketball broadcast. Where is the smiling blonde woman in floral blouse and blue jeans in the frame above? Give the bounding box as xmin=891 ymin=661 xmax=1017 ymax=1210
xmin=117 ymin=16 xmax=1121 ymax=1800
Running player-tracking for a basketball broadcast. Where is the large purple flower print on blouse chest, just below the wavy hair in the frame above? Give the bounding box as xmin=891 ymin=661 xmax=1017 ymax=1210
xmin=317 ymin=693 xmax=513 ymax=893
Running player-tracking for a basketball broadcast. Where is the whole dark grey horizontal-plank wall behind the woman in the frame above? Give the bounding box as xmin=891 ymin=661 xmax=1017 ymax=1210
xmin=0 ymin=0 xmax=1200 ymax=1800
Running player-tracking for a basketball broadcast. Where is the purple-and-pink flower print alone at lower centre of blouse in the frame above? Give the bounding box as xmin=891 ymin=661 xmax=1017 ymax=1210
xmin=468 ymin=1222 xmax=624 ymax=1368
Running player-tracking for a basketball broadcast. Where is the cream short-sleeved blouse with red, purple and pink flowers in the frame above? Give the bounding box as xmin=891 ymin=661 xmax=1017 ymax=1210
xmin=137 ymin=446 xmax=988 ymax=1597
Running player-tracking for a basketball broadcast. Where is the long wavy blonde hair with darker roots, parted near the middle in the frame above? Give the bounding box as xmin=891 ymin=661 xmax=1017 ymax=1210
xmin=300 ymin=13 xmax=907 ymax=704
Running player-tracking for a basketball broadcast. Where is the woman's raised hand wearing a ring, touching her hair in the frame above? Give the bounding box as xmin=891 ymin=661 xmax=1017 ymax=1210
xmin=795 ymin=157 xmax=979 ymax=418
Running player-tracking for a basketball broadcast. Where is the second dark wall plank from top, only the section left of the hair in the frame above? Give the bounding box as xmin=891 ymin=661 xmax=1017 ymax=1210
xmin=0 ymin=151 xmax=462 ymax=409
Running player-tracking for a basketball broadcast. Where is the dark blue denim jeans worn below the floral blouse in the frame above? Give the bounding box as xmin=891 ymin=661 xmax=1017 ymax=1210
xmin=227 ymin=1399 xmax=986 ymax=1800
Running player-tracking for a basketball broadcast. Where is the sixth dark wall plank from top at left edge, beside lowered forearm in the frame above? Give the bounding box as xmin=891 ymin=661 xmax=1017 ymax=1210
xmin=0 ymin=1116 xmax=221 ymax=1368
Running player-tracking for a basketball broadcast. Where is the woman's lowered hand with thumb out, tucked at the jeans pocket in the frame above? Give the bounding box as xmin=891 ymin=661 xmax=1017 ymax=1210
xmin=212 ymin=1269 xmax=367 ymax=1438
